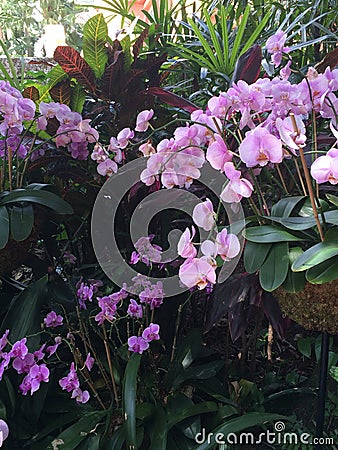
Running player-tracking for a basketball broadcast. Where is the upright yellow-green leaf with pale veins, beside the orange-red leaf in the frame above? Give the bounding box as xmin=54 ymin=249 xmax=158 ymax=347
xmin=83 ymin=14 xmax=108 ymax=78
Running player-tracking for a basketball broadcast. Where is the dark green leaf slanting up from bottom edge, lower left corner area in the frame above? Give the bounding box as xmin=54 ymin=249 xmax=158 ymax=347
xmin=52 ymin=411 xmax=107 ymax=450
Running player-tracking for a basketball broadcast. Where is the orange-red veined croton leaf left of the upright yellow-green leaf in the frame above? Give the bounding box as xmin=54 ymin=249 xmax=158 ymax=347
xmin=54 ymin=46 xmax=95 ymax=92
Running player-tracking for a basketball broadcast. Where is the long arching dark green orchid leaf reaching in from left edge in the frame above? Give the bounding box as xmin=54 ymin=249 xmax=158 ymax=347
xmin=0 ymin=189 xmax=73 ymax=214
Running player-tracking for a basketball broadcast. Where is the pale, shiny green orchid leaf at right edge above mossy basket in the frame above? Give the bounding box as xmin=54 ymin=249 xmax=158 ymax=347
xmin=292 ymin=228 xmax=338 ymax=272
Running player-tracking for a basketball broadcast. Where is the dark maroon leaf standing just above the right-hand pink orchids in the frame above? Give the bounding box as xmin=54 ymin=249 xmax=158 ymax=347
xmin=231 ymin=44 xmax=262 ymax=84
